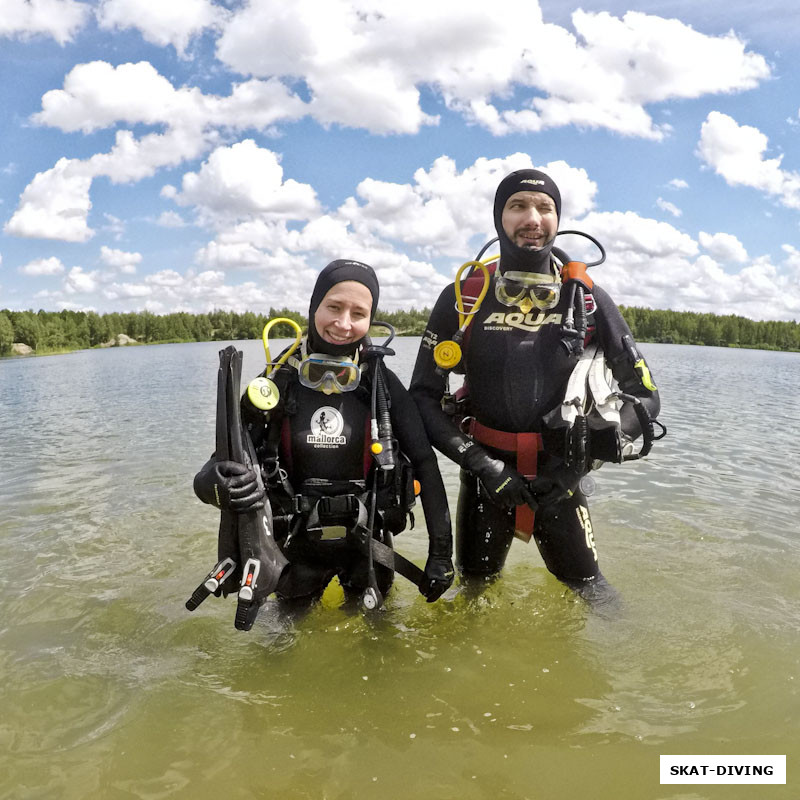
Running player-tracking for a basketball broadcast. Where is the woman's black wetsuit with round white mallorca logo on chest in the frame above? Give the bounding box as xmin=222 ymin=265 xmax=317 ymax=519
xmin=243 ymin=366 xmax=451 ymax=598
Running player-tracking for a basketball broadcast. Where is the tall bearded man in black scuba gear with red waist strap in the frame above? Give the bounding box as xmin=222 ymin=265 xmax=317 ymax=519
xmin=410 ymin=169 xmax=660 ymax=600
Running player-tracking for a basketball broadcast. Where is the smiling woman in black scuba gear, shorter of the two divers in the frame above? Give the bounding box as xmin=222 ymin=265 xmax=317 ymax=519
xmin=194 ymin=260 xmax=453 ymax=608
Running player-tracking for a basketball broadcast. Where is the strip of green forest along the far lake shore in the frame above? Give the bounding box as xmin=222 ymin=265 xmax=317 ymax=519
xmin=0 ymin=306 xmax=800 ymax=355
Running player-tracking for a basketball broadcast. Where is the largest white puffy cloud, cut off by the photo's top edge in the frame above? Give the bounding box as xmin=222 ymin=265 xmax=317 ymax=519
xmin=212 ymin=0 xmax=770 ymax=139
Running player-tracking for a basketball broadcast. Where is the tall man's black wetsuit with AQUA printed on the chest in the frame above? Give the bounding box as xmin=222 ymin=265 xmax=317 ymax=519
xmin=410 ymin=268 xmax=659 ymax=585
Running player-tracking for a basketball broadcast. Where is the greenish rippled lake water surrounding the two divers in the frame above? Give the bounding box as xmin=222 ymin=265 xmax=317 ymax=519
xmin=0 ymin=339 xmax=800 ymax=800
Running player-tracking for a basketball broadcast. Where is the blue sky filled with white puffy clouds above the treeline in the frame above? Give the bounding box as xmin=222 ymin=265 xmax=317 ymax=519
xmin=0 ymin=0 xmax=800 ymax=320
